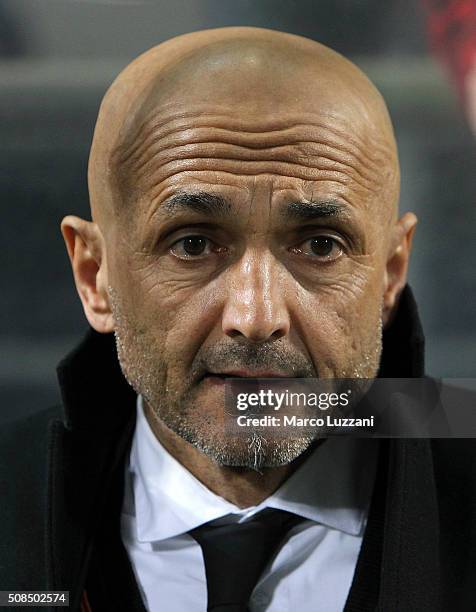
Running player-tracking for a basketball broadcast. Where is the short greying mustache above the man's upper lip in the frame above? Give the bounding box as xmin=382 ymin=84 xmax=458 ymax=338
xmin=192 ymin=341 xmax=318 ymax=381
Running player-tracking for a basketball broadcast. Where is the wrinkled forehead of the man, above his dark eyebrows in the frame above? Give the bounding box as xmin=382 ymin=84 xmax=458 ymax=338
xmin=114 ymin=107 xmax=391 ymax=220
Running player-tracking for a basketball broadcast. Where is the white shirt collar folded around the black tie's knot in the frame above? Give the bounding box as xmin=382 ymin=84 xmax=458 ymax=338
xmin=123 ymin=396 xmax=377 ymax=542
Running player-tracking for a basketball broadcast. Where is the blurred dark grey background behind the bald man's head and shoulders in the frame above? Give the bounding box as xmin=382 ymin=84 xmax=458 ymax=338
xmin=0 ymin=0 xmax=476 ymax=422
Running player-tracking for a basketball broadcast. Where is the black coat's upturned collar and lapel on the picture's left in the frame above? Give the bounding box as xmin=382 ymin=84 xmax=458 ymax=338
xmin=47 ymin=331 xmax=135 ymax=609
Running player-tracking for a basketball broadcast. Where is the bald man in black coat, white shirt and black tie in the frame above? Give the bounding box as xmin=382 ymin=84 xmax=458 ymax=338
xmin=0 ymin=28 xmax=476 ymax=612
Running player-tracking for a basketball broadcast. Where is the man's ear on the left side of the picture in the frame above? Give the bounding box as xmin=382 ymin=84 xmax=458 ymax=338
xmin=61 ymin=215 xmax=114 ymax=334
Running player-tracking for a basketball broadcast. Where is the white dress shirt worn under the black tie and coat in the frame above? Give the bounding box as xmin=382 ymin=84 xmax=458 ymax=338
xmin=121 ymin=396 xmax=377 ymax=612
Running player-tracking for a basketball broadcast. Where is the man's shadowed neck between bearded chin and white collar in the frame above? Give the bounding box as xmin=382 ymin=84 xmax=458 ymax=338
xmin=144 ymin=401 xmax=307 ymax=508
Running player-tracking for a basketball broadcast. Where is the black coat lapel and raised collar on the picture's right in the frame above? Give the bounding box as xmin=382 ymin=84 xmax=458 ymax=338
xmin=378 ymin=286 xmax=440 ymax=612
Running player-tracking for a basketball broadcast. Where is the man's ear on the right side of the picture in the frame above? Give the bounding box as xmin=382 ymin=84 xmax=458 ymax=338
xmin=383 ymin=212 xmax=418 ymax=326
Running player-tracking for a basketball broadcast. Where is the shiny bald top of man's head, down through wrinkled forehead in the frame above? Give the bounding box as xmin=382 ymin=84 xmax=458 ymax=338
xmin=88 ymin=28 xmax=399 ymax=225
